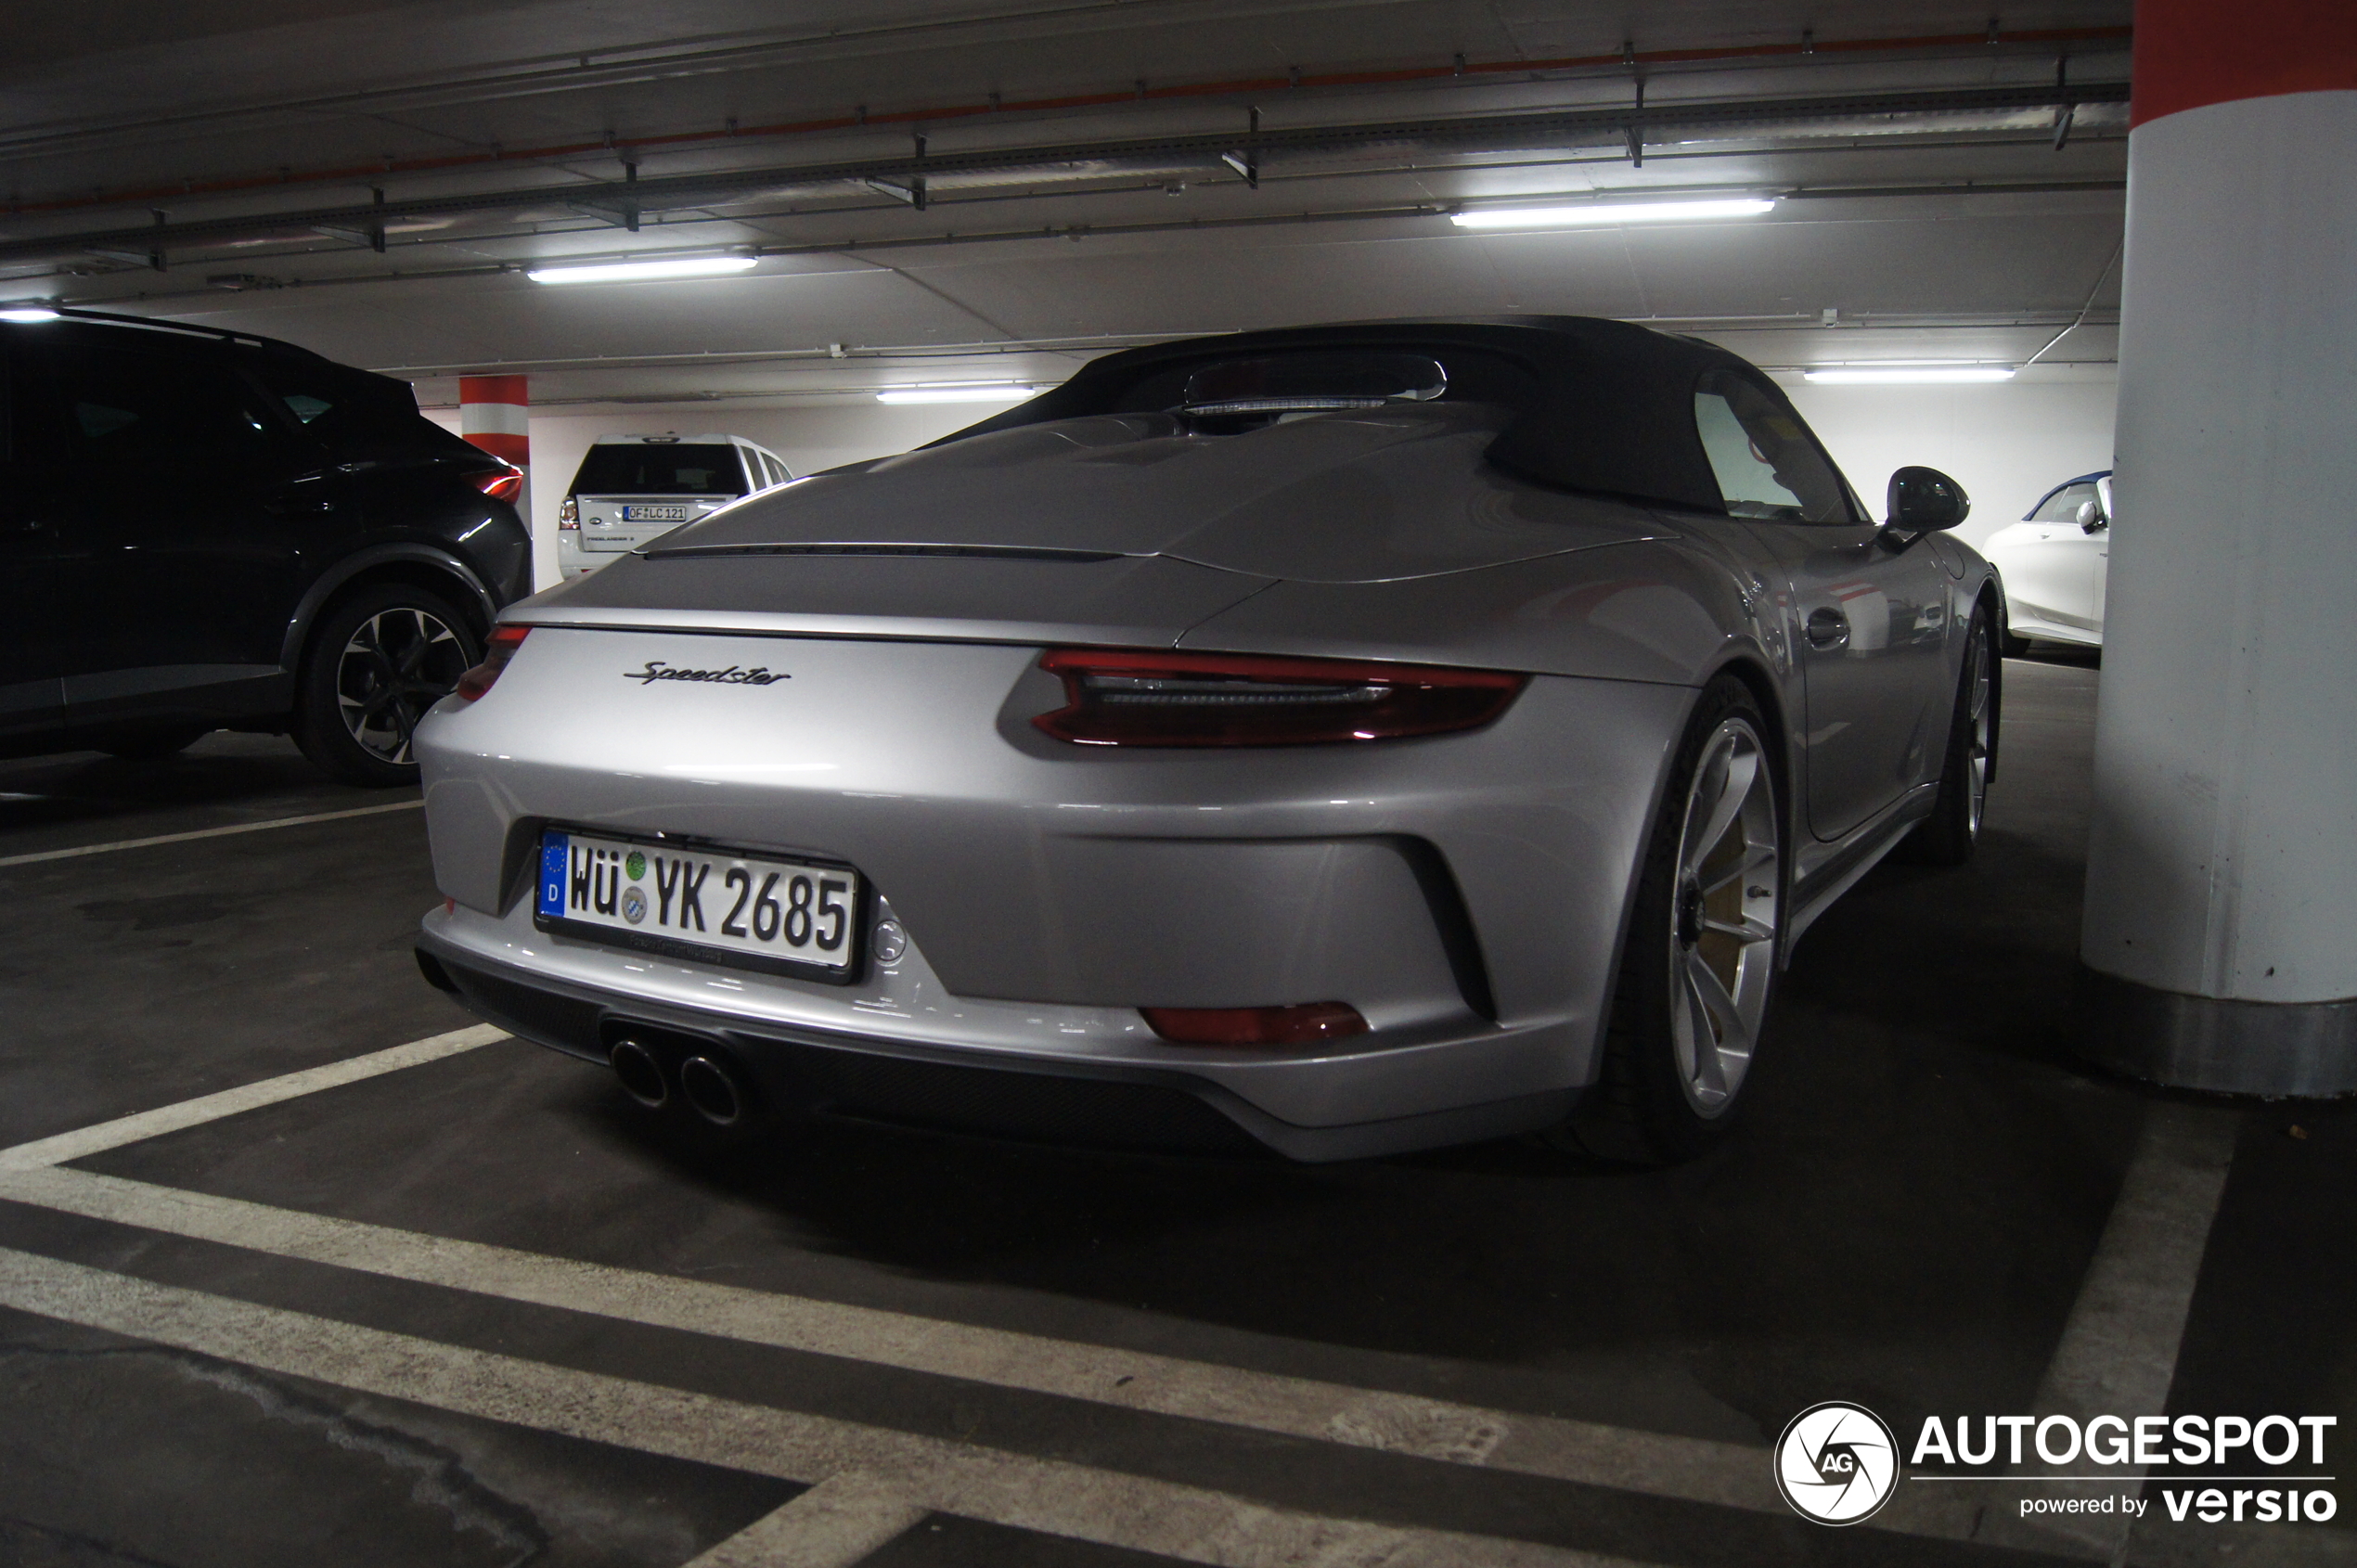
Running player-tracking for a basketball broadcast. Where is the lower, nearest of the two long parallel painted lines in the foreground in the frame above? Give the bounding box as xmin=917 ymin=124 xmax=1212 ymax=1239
xmin=0 ymin=1250 xmax=1659 ymax=1568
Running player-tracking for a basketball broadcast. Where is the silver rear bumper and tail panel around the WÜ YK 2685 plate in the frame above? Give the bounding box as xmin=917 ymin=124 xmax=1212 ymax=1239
xmin=418 ymin=624 xmax=1693 ymax=1158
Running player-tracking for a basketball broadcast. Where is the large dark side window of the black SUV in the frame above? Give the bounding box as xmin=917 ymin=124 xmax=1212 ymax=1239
xmin=57 ymin=349 xmax=283 ymax=471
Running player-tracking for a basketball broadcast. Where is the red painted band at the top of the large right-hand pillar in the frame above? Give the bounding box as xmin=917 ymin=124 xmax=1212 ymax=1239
xmin=2129 ymin=0 xmax=2357 ymax=127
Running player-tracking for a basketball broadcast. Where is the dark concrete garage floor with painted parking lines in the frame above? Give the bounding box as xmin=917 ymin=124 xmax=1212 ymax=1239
xmin=0 ymin=655 xmax=2357 ymax=1568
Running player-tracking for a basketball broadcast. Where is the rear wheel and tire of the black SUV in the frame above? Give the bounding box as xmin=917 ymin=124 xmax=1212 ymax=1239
xmin=295 ymin=583 xmax=483 ymax=788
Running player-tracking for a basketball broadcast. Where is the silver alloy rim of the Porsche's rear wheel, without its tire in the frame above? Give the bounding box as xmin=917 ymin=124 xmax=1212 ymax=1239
xmin=1668 ymin=717 xmax=1784 ymax=1120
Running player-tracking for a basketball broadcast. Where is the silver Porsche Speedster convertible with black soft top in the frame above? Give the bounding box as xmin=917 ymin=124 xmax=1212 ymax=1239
xmin=415 ymin=318 xmax=1999 ymax=1160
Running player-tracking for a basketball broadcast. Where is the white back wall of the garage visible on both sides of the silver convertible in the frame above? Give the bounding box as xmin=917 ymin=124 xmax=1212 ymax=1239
xmin=429 ymin=370 xmax=2119 ymax=587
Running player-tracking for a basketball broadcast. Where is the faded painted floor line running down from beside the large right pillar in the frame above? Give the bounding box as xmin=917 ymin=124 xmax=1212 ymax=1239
xmin=1980 ymin=1103 xmax=2242 ymax=1561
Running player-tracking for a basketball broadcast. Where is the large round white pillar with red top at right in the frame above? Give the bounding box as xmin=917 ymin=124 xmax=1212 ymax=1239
xmin=2081 ymin=0 xmax=2357 ymax=1094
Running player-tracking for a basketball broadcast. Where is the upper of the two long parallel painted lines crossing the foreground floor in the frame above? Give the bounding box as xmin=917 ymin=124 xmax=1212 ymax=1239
xmin=0 ymin=1155 xmax=1800 ymax=1537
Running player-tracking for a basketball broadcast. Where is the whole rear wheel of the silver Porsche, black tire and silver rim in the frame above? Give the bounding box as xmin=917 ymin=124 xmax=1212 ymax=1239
xmin=1541 ymin=676 xmax=1784 ymax=1164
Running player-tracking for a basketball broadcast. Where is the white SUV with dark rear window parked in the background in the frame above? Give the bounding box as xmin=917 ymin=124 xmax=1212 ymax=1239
xmin=556 ymin=436 xmax=794 ymax=583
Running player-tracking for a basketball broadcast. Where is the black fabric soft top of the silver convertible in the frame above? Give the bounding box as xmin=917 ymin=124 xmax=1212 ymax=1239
xmin=935 ymin=316 xmax=1808 ymax=511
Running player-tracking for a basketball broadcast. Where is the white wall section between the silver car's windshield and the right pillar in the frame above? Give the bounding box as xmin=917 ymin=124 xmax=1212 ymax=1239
xmin=1786 ymin=373 xmax=2119 ymax=547
